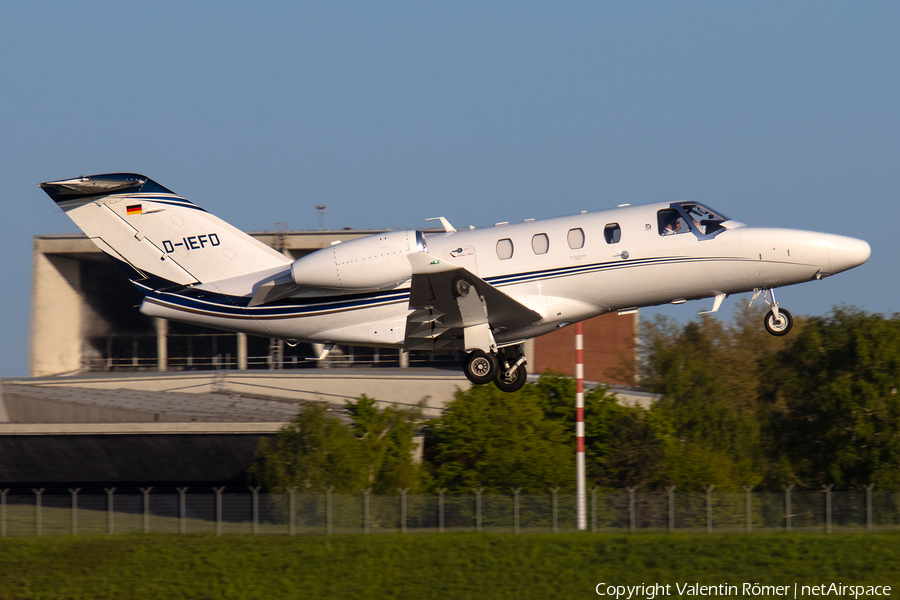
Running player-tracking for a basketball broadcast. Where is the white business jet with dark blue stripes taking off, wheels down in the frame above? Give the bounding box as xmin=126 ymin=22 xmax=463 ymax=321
xmin=40 ymin=173 xmax=870 ymax=391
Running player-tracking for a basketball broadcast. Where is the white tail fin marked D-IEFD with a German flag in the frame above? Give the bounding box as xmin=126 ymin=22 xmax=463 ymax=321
xmin=40 ymin=173 xmax=291 ymax=289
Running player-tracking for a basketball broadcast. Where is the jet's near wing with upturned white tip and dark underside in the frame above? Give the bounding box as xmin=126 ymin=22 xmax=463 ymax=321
xmin=405 ymin=252 xmax=543 ymax=350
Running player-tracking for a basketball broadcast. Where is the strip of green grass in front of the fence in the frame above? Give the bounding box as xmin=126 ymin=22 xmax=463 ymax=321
xmin=0 ymin=533 xmax=900 ymax=599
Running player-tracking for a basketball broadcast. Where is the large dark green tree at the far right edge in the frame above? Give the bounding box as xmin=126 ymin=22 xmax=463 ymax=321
xmin=764 ymin=307 xmax=900 ymax=489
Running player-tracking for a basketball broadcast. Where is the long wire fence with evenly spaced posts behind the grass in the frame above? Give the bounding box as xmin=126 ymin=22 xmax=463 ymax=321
xmin=0 ymin=486 xmax=900 ymax=536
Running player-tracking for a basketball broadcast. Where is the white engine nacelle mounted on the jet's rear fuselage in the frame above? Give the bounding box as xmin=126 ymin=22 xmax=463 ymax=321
xmin=291 ymin=229 xmax=428 ymax=291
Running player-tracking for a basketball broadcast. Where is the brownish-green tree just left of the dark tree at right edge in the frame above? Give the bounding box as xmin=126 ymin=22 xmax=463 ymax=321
xmin=641 ymin=307 xmax=784 ymax=491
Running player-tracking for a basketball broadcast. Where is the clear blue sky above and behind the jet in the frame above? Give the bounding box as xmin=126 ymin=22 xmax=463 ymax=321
xmin=0 ymin=0 xmax=900 ymax=376
